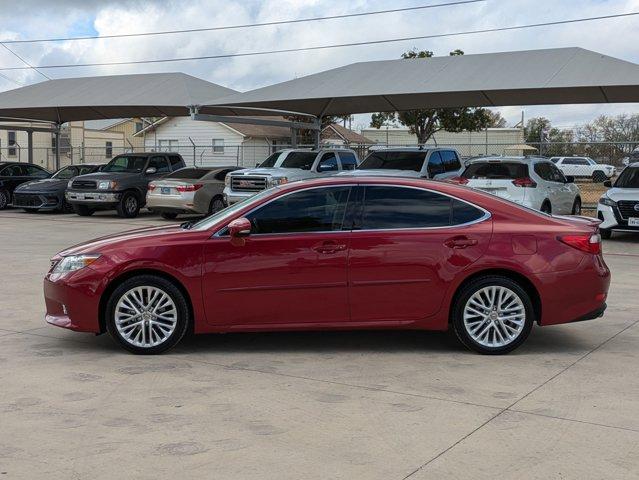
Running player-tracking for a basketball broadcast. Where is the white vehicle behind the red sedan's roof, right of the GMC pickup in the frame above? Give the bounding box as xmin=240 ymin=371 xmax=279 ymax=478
xmin=350 ymin=147 xmax=462 ymax=180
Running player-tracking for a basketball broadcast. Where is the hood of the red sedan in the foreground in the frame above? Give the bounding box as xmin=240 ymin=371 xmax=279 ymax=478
xmin=56 ymin=225 xmax=189 ymax=257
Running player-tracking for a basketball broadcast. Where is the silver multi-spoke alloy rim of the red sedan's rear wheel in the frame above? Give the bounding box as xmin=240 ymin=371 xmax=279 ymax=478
xmin=464 ymin=286 xmax=526 ymax=348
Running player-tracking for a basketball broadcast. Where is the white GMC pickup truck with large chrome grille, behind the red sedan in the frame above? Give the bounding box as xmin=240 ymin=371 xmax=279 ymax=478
xmin=223 ymin=148 xmax=359 ymax=205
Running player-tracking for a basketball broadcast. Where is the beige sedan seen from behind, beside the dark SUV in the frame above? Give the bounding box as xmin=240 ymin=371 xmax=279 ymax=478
xmin=146 ymin=166 xmax=241 ymax=219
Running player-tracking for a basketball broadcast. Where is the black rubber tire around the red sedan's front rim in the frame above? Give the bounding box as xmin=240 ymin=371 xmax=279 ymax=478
xmin=105 ymin=275 xmax=190 ymax=355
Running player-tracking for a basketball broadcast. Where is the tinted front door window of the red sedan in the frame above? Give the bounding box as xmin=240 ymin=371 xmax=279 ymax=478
xmin=246 ymin=187 xmax=350 ymax=233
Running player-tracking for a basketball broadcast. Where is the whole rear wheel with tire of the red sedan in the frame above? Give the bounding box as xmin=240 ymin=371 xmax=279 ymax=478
xmin=452 ymin=275 xmax=535 ymax=355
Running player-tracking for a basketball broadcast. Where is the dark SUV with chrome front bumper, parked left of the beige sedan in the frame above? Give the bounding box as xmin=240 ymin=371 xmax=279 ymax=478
xmin=66 ymin=152 xmax=186 ymax=218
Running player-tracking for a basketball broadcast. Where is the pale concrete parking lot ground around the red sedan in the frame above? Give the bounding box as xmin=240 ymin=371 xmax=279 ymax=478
xmin=0 ymin=211 xmax=639 ymax=480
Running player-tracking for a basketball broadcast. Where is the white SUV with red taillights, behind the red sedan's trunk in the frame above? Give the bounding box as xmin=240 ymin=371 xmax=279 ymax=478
xmin=452 ymin=157 xmax=581 ymax=215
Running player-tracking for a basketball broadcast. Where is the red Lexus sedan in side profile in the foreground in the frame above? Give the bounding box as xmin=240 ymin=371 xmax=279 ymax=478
xmin=44 ymin=177 xmax=610 ymax=354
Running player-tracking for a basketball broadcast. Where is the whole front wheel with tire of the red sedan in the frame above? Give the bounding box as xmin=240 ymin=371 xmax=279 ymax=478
xmin=106 ymin=275 xmax=189 ymax=354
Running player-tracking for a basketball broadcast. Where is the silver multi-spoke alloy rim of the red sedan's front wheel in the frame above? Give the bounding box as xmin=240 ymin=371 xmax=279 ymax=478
xmin=115 ymin=286 xmax=178 ymax=348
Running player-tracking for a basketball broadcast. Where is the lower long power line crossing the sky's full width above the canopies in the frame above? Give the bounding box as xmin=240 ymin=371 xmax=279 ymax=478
xmin=0 ymin=12 xmax=639 ymax=71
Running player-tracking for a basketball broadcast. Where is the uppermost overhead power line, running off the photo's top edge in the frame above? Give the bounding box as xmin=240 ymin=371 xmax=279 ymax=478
xmin=2 ymin=0 xmax=486 ymax=44
